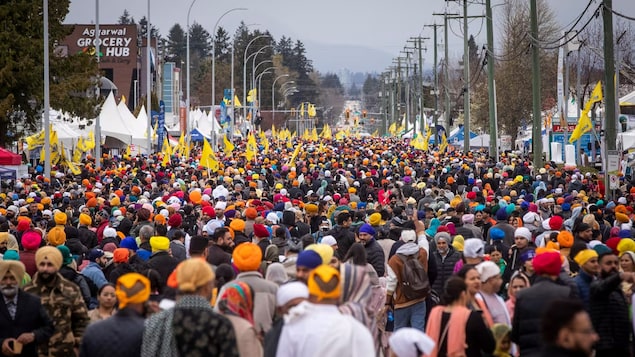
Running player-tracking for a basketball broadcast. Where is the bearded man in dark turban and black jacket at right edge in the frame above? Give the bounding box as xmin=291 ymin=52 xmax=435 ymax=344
xmin=589 ymin=250 xmax=635 ymax=357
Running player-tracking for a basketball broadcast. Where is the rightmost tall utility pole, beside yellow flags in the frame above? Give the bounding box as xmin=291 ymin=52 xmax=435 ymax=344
xmin=602 ymin=0 xmax=617 ymax=197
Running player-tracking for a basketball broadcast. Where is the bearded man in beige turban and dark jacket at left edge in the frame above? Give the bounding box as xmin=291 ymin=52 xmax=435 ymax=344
xmin=0 ymin=260 xmax=53 ymax=357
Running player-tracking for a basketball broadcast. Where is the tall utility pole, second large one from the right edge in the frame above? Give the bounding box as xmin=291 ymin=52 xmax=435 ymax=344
xmin=529 ymin=0 xmax=542 ymax=167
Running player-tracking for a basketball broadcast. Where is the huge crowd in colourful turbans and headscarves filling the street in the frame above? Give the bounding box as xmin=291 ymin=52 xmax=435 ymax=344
xmin=0 ymin=137 xmax=635 ymax=357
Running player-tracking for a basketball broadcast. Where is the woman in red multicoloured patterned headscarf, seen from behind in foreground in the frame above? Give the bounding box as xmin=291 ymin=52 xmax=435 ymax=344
xmin=216 ymin=281 xmax=263 ymax=357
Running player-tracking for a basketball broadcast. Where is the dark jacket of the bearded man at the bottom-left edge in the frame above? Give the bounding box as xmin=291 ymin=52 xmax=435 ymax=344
xmin=0 ymin=290 xmax=54 ymax=357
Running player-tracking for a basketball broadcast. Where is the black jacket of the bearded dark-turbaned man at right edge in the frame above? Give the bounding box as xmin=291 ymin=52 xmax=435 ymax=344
xmin=589 ymin=273 xmax=633 ymax=351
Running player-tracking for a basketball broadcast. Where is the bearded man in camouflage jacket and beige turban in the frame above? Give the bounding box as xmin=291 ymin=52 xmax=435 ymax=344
xmin=24 ymin=246 xmax=90 ymax=357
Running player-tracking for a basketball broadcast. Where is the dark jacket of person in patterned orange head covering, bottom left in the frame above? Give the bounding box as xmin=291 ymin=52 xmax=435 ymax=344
xmin=79 ymin=309 xmax=145 ymax=357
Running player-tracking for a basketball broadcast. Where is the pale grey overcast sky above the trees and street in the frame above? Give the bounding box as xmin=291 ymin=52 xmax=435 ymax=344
xmin=66 ymin=0 xmax=635 ymax=72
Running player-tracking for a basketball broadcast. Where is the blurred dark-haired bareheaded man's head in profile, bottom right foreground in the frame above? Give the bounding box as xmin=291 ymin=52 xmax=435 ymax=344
xmin=541 ymin=300 xmax=600 ymax=357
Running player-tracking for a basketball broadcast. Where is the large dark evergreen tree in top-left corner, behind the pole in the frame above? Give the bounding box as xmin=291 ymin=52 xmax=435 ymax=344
xmin=0 ymin=0 xmax=98 ymax=146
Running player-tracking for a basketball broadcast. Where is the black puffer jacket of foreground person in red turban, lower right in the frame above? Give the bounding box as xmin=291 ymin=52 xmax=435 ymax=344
xmin=512 ymin=277 xmax=574 ymax=357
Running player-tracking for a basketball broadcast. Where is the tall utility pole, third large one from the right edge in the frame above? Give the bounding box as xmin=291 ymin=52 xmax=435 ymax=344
xmin=485 ymin=0 xmax=498 ymax=157
